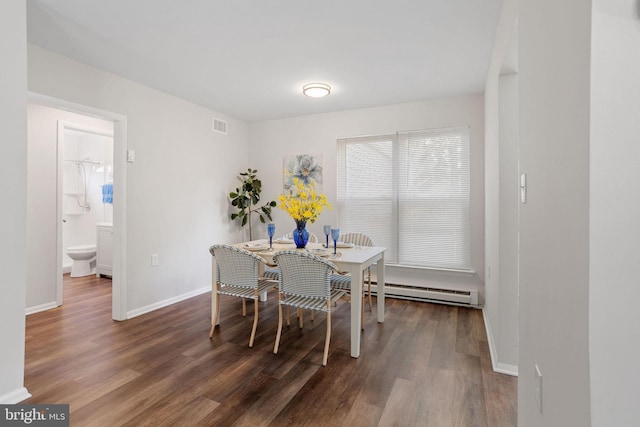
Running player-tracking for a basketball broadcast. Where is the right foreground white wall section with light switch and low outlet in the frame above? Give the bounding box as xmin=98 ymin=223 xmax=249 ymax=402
xmin=518 ymin=0 xmax=592 ymax=427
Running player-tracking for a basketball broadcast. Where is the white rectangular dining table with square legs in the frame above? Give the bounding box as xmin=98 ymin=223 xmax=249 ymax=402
xmin=211 ymin=241 xmax=387 ymax=357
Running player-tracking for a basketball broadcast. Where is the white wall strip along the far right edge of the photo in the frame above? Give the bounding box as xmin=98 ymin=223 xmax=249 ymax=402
xmin=589 ymin=0 xmax=640 ymax=426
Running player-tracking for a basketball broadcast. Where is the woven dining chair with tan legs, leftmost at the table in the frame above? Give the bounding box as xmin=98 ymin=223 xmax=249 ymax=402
xmin=209 ymin=245 xmax=278 ymax=347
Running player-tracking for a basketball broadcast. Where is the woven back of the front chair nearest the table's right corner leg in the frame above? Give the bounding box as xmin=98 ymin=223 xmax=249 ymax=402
xmin=273 ymin=250 xmax=337 ymax=299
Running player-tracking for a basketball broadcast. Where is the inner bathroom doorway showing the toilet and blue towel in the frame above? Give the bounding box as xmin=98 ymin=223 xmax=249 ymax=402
xmin=56 ymin=120 xmax=114 ymax=306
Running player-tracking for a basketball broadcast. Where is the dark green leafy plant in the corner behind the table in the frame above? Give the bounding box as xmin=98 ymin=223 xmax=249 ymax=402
xmin=229 ymin=168 xmax=276 ymax=240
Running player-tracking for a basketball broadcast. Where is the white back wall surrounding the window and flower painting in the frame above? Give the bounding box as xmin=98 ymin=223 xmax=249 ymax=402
xmin=249 ymin=94 xmax=484 ymax=294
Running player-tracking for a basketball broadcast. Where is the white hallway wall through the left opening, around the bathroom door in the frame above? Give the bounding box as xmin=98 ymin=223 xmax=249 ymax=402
xmin=26 ymin=103 xmax=113 ymax=311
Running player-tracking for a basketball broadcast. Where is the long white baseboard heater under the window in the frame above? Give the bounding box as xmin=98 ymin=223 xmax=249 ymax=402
xmin=365 ymin=283 xmax=479 ymax=307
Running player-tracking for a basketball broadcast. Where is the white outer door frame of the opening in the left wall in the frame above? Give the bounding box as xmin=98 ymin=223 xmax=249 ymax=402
xmin=28 ymin=92 xmax=127 ymax=320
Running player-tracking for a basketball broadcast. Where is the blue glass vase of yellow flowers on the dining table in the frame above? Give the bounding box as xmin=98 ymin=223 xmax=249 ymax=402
xmin=278 ymin=178 xmax=332 ymax=248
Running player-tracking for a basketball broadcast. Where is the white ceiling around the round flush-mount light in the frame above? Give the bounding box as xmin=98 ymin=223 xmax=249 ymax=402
xmin=27 ymin=0 xmax=501 ymax=122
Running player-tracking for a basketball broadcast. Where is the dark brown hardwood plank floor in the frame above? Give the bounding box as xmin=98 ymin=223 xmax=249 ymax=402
xmin=24 ymin=276 xmax=517 ymax=427
